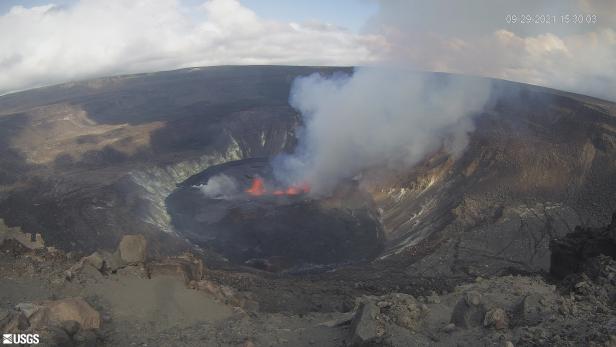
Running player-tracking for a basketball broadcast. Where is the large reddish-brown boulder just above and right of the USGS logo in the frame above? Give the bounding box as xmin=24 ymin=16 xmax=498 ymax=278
xmin=30 ymin=297 xmax=101 ymax=329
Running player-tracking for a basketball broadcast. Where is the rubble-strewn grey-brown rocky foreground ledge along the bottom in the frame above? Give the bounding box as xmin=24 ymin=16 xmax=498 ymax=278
xmin=0 ymin=214 xmax=616 ymax=346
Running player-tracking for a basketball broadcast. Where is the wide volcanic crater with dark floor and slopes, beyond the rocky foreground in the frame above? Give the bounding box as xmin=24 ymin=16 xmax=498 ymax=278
xmin=0 ymin=66 xmax=616 ymax=294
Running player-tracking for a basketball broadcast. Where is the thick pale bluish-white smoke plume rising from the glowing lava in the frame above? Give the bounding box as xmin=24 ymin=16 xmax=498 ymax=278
xmin=274 ymin=68 xmax=490 ymax=194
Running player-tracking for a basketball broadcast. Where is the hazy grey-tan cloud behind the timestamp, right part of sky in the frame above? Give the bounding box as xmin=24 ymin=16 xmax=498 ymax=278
xmin=369 ymin=0 xmax=616 ymax=101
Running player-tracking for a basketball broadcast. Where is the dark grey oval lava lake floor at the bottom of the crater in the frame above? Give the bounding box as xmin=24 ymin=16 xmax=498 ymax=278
xmin=165 ymin=158 xmax=384 ymax=272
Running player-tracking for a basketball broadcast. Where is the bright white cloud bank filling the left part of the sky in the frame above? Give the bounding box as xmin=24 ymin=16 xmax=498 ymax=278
xmin=0 ymin=0 xmax=378 ymax=94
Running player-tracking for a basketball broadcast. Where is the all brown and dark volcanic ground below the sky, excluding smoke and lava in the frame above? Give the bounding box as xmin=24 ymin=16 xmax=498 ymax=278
xmin=0 ymin=66 xmax=616 ymax=346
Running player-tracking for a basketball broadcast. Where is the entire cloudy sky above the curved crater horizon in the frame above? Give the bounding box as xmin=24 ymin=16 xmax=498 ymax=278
xmin=0 ymin=0 xmax=616 ymax=100
